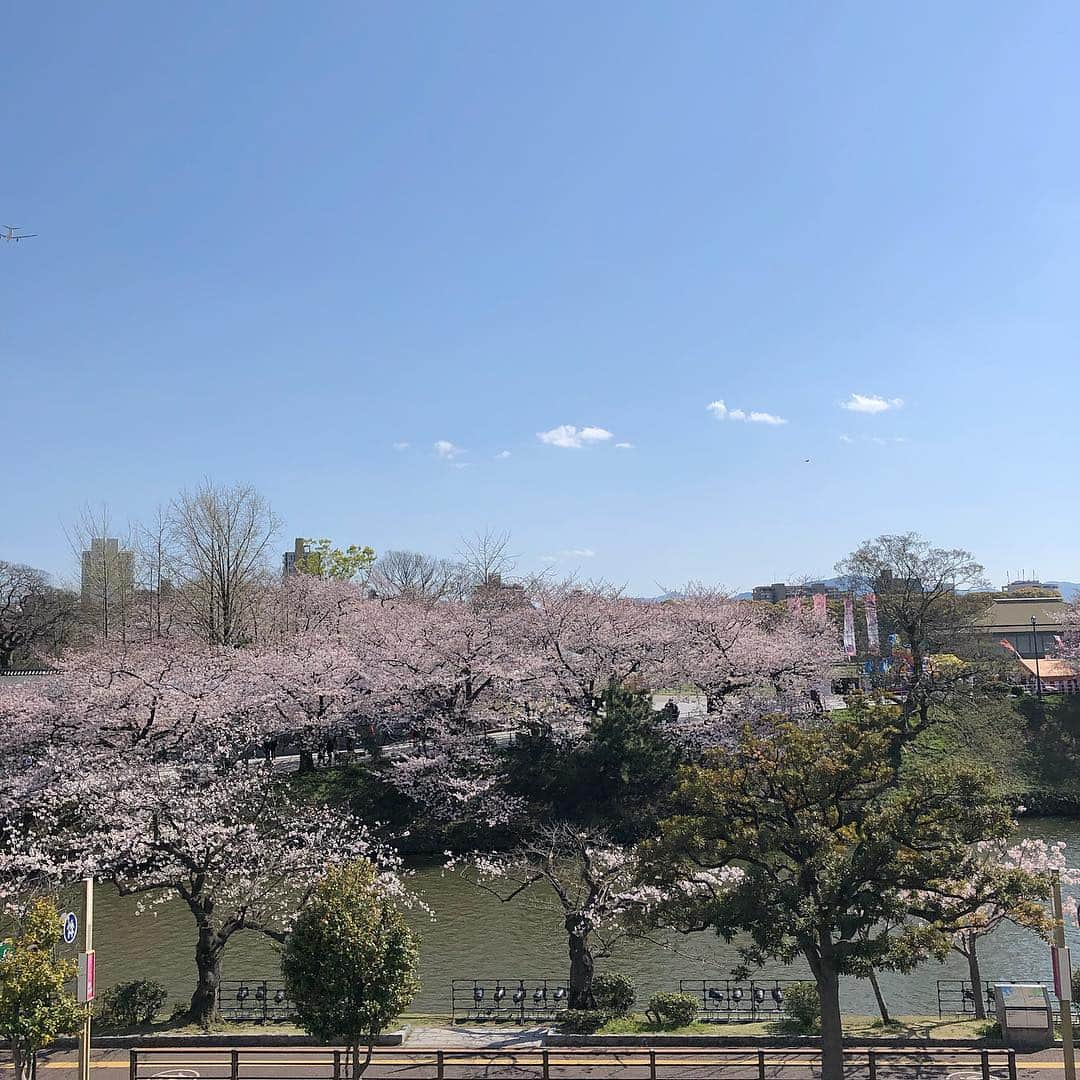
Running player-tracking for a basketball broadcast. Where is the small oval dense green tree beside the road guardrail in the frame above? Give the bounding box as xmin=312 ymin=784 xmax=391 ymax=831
xmin=281 ymin=860 xmax=420 ymax=1077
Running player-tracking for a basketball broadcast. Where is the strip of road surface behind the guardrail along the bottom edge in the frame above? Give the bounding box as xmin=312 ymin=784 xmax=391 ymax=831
xmin=0 ymin=1047 xmax=1064 ymax=1080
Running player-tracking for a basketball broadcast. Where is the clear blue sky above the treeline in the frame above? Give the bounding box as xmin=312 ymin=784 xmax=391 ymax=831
xmin=0 ymin=0 xmax=1080 ymax=592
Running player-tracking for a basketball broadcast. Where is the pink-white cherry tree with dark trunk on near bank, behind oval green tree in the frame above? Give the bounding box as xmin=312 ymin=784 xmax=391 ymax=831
xmin=83 ymin=761 xmax=400 ymax=1024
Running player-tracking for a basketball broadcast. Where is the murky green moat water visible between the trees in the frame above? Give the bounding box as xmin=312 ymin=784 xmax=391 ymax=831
xmin=75 ymin=818 xmax=1080 ymax=1015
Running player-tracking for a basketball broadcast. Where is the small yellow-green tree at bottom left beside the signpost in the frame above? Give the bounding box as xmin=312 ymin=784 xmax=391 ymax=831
xmin=0 ymin=899 xmax=83 ymax=1080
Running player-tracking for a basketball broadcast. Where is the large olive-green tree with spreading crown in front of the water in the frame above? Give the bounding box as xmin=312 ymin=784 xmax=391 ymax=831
xmin=644 ymin=704 xmax=1012 ymax=1080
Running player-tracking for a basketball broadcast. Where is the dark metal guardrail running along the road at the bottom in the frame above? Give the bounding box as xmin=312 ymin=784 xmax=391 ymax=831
xmin=129 ymin=1047 xmax=1016 ymax=1080
